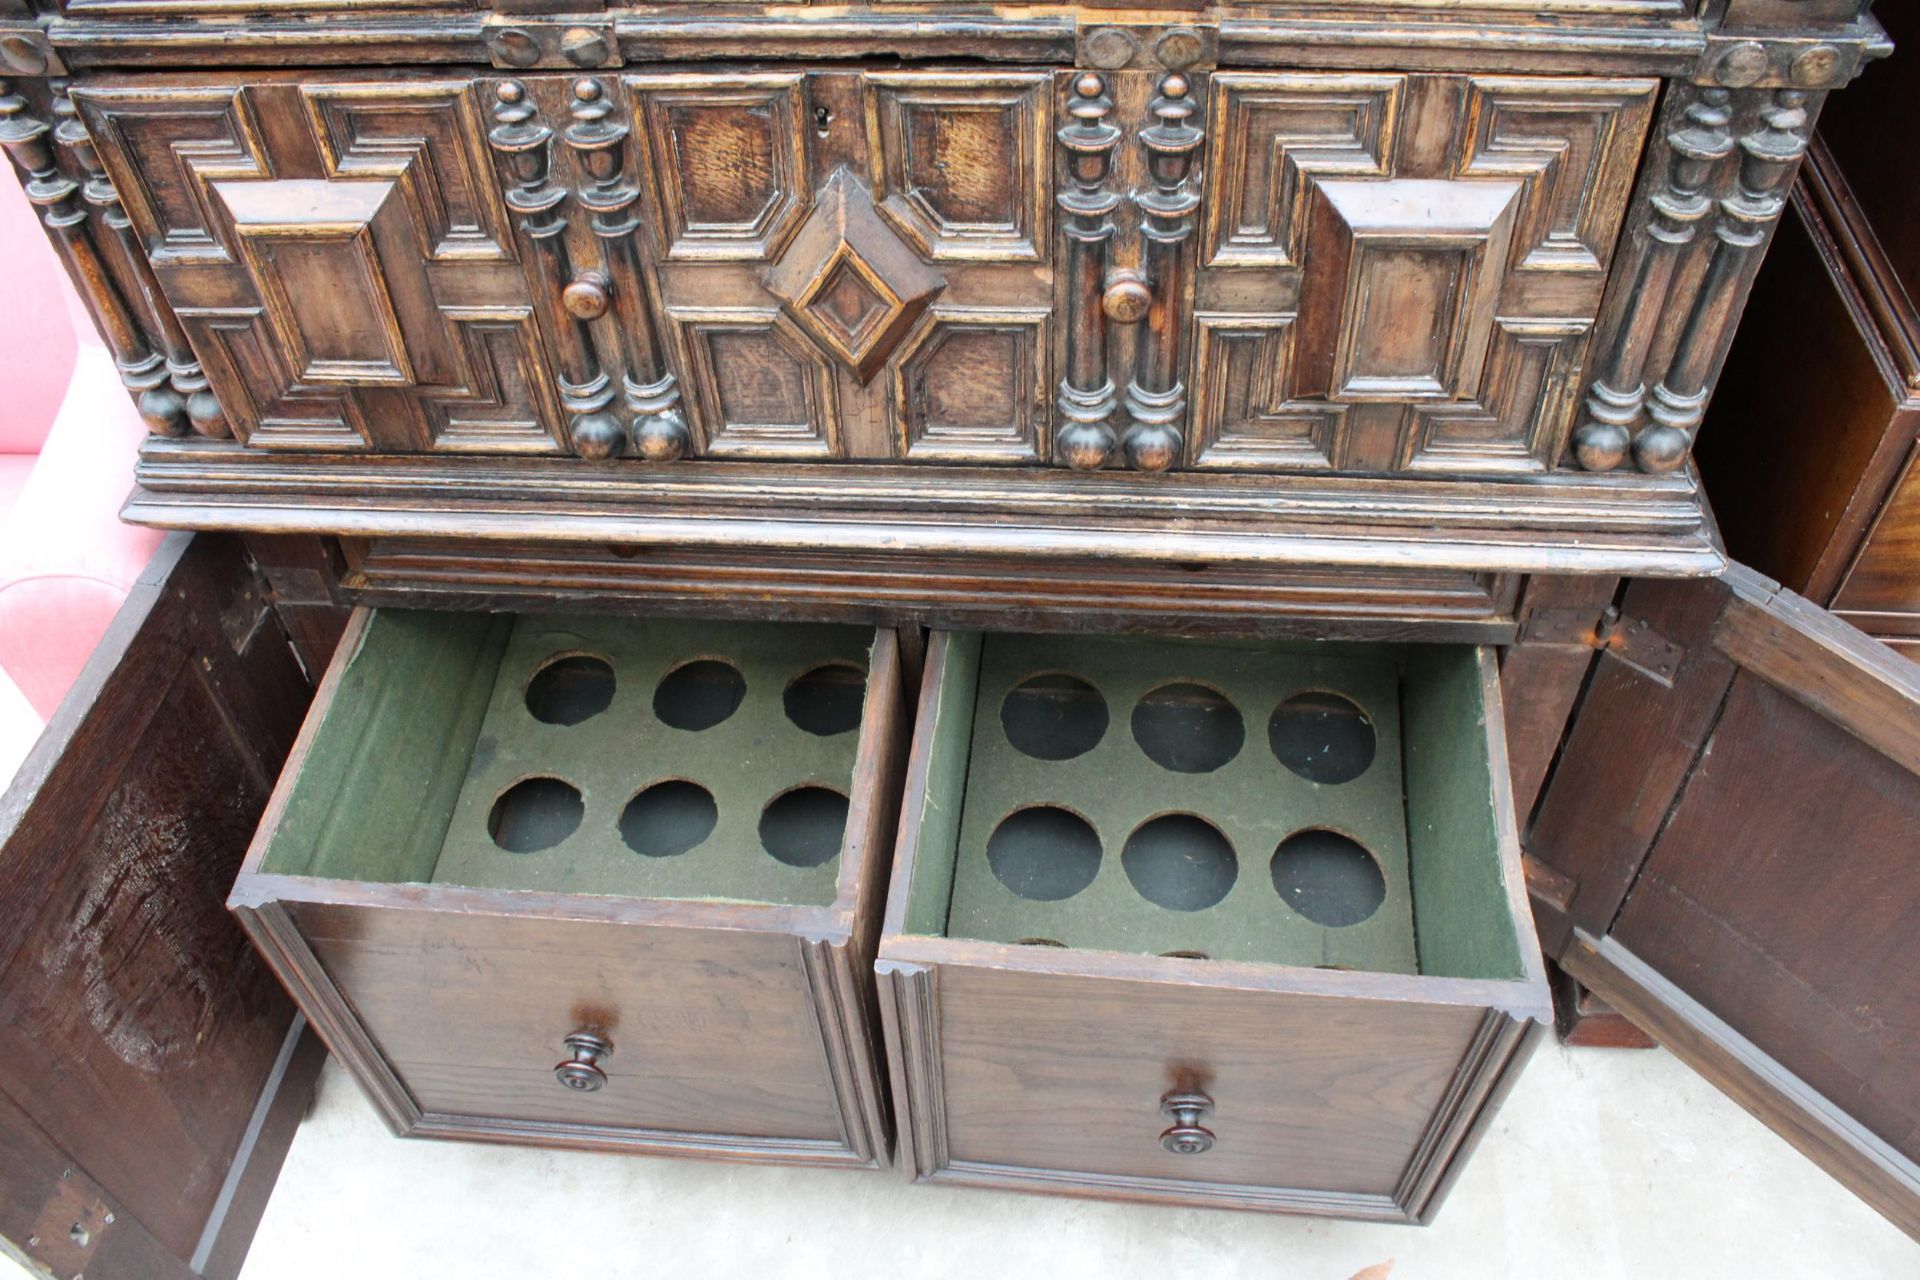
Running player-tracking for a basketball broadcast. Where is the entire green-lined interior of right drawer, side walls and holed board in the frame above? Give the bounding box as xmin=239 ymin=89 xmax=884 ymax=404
xmin=906 ymin=635 xmax=1523 ymax=979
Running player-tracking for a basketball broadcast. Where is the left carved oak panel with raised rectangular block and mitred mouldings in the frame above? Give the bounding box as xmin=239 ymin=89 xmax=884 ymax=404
xmin=75 ymin=75 xmax=564 ymax=453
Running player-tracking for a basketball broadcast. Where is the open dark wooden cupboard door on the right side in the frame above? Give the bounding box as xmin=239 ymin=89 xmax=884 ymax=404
xmin=1526 ymin=566 xmax=1920 ymax=1236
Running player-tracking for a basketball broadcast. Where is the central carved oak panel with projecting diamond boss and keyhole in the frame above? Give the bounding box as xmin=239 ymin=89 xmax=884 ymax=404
xmin=618 ymin=71 xmax=1056 ymax=462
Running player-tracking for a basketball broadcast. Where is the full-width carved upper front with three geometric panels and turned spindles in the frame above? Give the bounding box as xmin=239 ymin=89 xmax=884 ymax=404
xmin=73 ymin=67 xmax=1657 ymax=474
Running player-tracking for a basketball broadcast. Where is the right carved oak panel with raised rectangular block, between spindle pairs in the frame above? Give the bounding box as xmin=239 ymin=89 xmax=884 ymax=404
xmin=1187 ymin=73 xmax=1657 ymax=472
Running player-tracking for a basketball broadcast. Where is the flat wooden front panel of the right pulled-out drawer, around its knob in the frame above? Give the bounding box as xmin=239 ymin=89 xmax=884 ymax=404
xmin=937 ymin=965 xmax=1505 ymax=1207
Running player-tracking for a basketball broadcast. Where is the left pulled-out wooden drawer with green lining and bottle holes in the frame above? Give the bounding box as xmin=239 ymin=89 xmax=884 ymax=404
xmin=230 ymin=610 xmax=904 ymax=1165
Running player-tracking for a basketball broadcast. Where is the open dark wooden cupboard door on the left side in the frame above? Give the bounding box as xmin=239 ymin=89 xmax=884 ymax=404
xmin=0 ymin=533 xmax=324 ymax=1280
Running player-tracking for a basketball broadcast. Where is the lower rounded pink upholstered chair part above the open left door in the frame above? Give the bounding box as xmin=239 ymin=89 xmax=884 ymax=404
xmin=0 ymin=344 xmax=161 ymax=718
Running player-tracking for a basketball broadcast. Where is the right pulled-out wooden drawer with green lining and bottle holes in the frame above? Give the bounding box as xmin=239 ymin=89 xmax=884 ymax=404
xmin=877 ymin=633 xmax=1549 ymax=1221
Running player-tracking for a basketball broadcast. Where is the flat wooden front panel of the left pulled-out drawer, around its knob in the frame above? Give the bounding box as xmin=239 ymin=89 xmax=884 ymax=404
xmin=290 ymin=904 xmax=845 ymax=1146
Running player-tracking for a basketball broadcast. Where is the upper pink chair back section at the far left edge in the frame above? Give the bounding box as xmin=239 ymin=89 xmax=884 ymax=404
xmin=0 ymin=164 xmax=79 ymax=455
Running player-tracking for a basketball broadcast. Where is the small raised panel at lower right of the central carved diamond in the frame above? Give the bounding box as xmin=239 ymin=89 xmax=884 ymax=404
xmin=893 ymin=307 xmax=1048 ymax=462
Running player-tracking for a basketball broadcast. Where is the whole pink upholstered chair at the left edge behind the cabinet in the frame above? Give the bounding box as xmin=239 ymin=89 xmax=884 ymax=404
xmin=0 ymin=166 xmax=159 ymax=785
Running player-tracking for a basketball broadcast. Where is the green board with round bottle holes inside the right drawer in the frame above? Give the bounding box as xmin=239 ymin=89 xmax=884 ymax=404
xmin=948 ymin=635 xmax=1415 ymax=973
